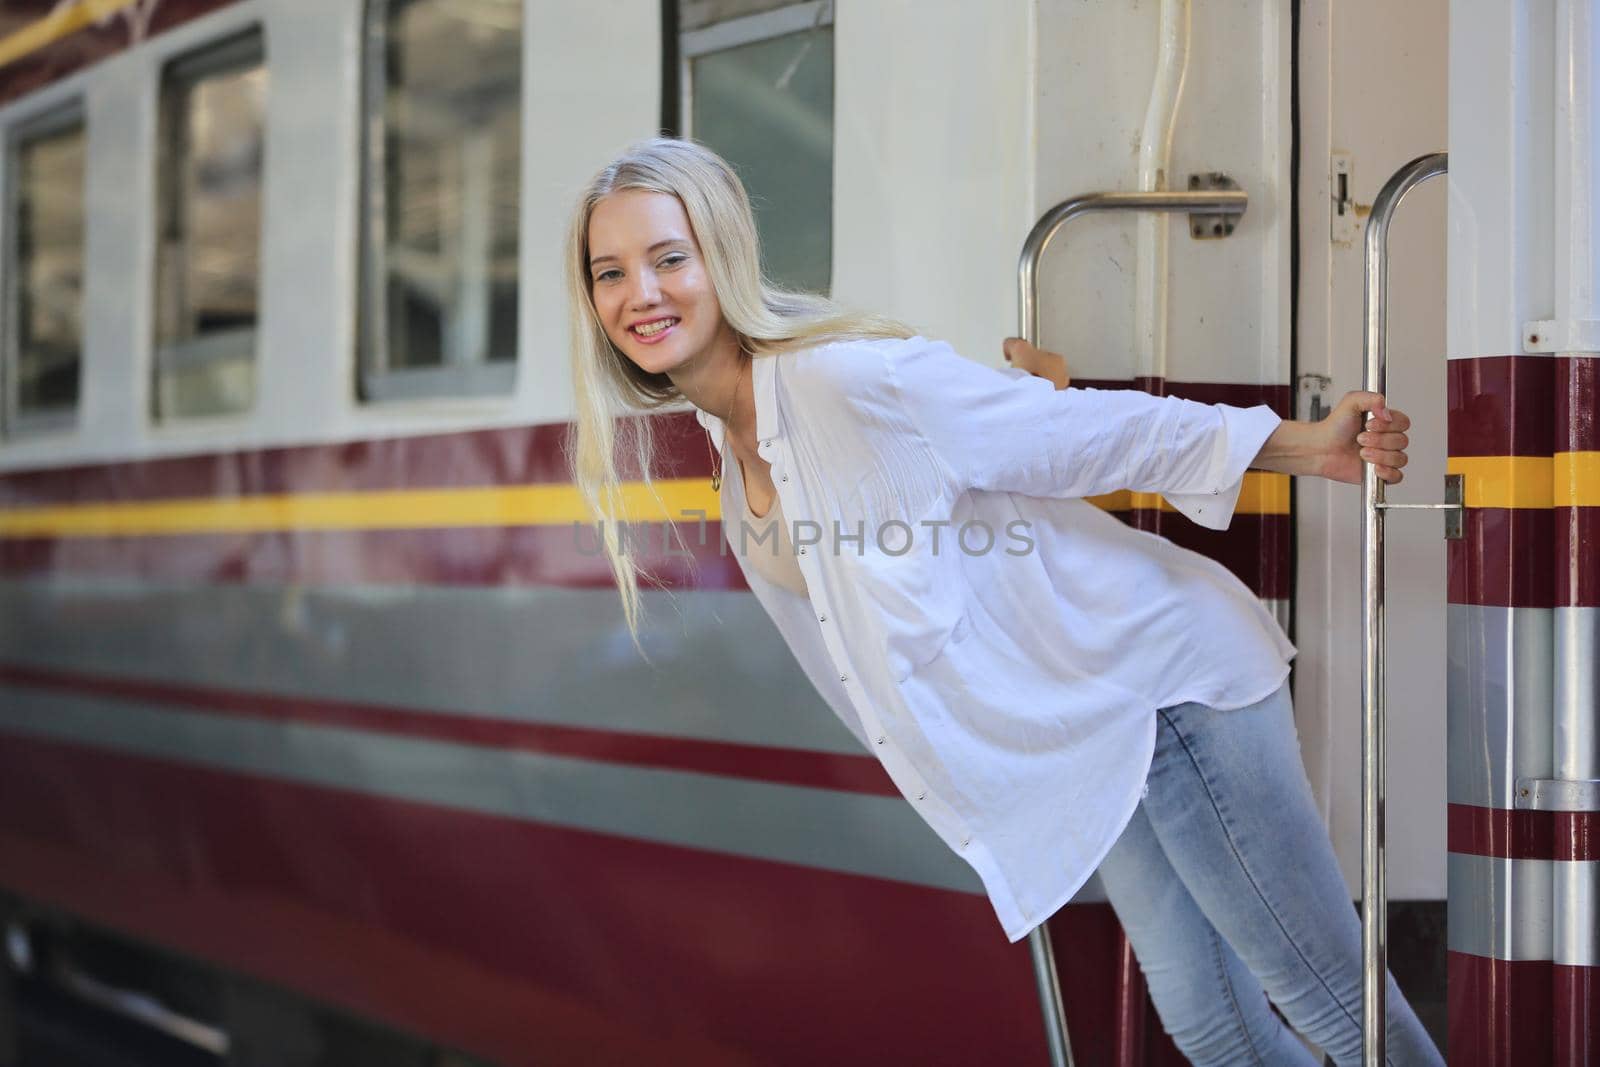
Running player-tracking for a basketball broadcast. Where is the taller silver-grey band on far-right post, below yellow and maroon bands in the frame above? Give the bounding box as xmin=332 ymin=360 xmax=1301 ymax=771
xmin=1445 ymin=605 xmax=1554 ymax=808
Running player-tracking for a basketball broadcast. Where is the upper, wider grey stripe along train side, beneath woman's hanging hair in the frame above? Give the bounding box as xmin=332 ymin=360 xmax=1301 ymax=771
xmin=0 ymin=577 xmax=861 ymax=755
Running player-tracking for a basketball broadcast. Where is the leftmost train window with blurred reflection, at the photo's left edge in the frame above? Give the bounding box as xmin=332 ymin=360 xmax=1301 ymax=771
xmin=5 ymin=106 xmax=85 ymax=434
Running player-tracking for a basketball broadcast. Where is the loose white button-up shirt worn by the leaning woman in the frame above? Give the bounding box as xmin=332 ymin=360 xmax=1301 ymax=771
xmin=698 ymin=338 xmax=1294 ymax=941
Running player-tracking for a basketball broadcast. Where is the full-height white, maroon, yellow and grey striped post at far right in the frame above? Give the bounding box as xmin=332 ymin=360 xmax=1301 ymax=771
xmin=1448 ymin=0 xmax=1600 ymax=1067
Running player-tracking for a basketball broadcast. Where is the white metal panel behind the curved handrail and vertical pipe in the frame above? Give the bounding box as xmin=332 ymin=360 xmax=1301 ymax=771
xmin=1034 ymin=0 xmax=1290 ymax=382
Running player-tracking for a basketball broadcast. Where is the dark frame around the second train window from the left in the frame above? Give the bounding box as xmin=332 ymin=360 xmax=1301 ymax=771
xmin=149 ymin=22 xmax=272 ymax=426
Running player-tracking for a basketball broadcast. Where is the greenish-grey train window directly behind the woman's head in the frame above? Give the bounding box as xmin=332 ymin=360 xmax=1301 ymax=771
xmin=678 ymin=0 xmax=834 ymax=293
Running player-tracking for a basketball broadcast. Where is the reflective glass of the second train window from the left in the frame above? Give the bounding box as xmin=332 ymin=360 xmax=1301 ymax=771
xmin=150 ymin=32 xmax=267 ymax=419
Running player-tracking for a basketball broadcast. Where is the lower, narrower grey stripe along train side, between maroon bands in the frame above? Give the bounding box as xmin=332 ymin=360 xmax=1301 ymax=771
xmin=0 ymin=686 xmax=982 ymax=894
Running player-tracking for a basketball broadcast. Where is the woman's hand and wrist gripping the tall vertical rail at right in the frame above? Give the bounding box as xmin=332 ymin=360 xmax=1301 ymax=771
xmin=1251 ymin=392 xmax=1411 ymax=485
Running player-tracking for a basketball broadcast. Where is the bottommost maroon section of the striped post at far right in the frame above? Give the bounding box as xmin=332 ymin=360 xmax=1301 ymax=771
xmin=1446 ymin=952 xmax=1554 ymax=1067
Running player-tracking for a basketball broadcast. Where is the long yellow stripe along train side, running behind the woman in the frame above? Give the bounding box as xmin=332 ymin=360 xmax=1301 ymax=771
xmin=0 ymin=472 xmax=1290 ymax=537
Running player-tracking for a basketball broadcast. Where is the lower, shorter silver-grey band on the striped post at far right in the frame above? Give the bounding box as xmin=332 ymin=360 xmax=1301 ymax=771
xmin=1445 ymin=853 xmax=1548 ymax=960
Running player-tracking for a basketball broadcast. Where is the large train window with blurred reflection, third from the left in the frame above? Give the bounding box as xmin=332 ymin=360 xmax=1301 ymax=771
xmin=360 ymin=0 xmax=522 ymax=400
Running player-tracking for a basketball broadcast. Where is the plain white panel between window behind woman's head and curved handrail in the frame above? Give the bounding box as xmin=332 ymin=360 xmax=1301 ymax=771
xmin=834 ymin=0 xmax=1036 ymax=365
